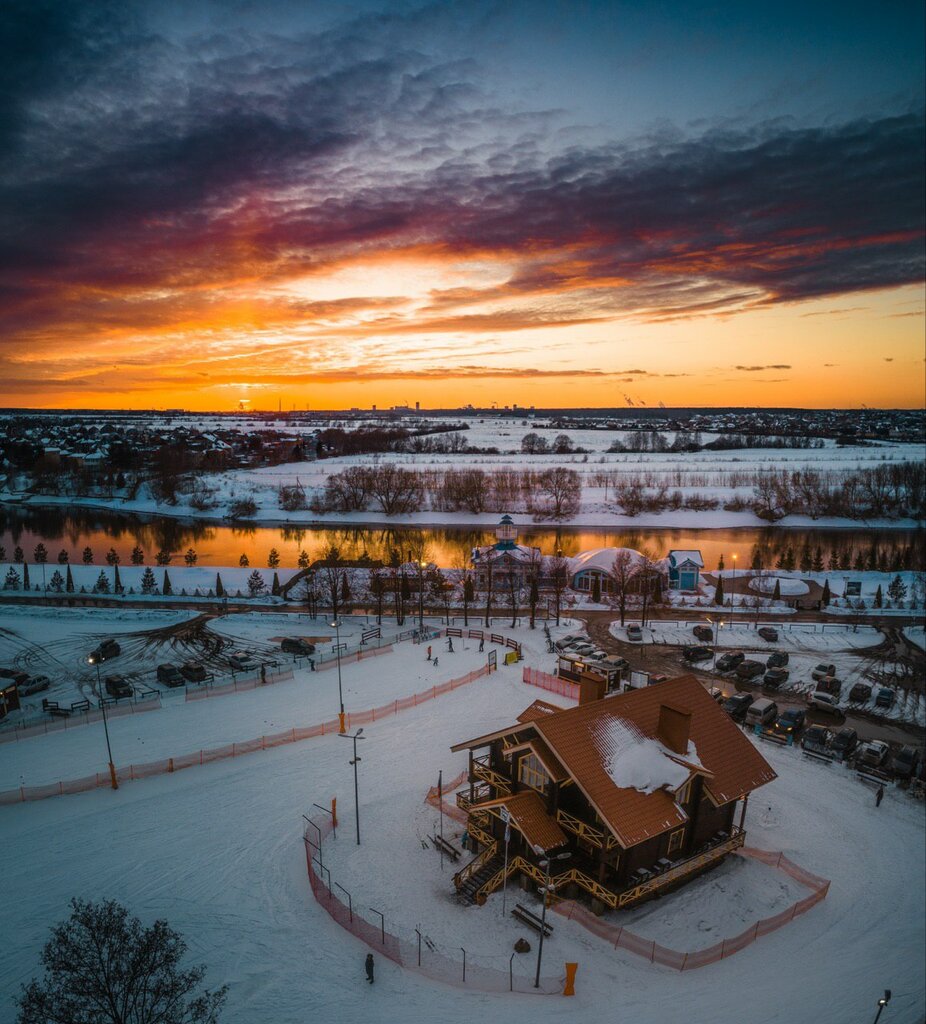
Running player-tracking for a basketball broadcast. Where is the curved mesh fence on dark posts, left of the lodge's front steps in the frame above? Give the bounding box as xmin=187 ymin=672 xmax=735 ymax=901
xmin=302 ymin=815 xmax=565 ymax=995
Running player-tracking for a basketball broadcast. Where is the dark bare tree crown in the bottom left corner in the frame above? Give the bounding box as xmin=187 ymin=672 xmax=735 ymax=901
xmin=16 ymin=899 xmax=227 ymax=1024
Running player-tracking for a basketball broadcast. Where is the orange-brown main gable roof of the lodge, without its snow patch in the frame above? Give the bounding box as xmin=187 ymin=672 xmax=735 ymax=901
xmin=533 ymin=676 xmax=776 ymax=848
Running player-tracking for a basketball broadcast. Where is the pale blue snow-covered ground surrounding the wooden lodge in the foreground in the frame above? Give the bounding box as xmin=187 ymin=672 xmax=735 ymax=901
xmin=0 ymin=614 xmax=926 ymax=1024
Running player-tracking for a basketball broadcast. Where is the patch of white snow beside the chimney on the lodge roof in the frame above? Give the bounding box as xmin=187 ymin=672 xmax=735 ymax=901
xmin=592 ymin=717 xmax=702 ymax=794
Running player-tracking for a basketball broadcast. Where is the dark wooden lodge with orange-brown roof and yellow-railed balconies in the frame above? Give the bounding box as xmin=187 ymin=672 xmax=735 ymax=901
xmin=452 ymin=676 xmax=775 ymax=913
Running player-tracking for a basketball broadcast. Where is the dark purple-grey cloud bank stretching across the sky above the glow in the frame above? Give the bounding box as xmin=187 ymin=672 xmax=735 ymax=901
xmin=0 ymin=0 xmax=924 ymax=348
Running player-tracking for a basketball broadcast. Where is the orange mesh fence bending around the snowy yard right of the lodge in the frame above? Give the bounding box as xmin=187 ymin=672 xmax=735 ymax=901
xmin=553 ymin=847 xmax=830 ymax=971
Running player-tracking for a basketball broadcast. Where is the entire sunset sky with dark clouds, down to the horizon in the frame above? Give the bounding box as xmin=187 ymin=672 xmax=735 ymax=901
xmin=0 ymin=0 xmax=926 ymax=410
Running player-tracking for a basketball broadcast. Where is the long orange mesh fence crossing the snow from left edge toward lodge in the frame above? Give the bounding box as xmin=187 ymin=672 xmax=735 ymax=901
xmin=0 ymin=665 xmax=491 ymax=807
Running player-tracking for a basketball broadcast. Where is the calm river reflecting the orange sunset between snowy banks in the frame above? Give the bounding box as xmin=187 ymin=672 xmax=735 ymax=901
xmin=0 ymin=506 xmax=926 ymax=569
